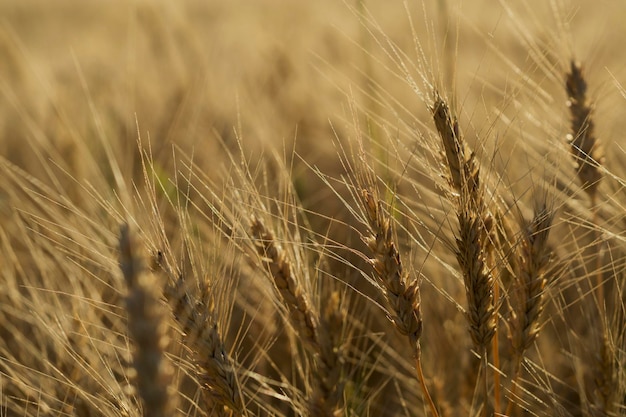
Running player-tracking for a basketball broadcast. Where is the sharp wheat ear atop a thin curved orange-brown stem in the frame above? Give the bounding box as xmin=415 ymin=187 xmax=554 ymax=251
xmin=361 ymin=190 xmax=439 ymax=416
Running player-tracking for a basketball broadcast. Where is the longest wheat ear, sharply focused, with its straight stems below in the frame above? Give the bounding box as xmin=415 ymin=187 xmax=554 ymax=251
xmin=431 ymin=91 xmax=500 ymax=415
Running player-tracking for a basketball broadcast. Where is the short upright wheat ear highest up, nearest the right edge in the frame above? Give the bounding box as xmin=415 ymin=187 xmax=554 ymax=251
xmin=565 ymin=61 xmax=604 ymax=201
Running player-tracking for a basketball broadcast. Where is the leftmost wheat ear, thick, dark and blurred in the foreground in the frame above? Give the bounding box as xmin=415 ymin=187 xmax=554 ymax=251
xmin=119 ymin=225 xmax=175 ymax=417
